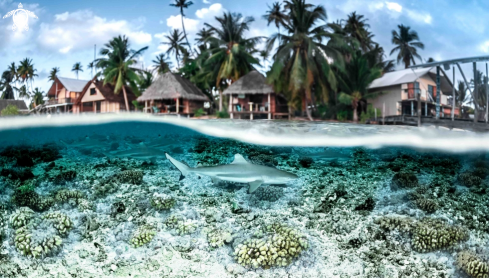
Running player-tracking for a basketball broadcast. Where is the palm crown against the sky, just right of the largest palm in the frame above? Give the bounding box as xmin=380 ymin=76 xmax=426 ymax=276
xmin=344 ymin=12 xmax=373 ymax=52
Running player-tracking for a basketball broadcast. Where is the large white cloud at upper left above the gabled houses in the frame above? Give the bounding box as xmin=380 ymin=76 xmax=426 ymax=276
xmin=38 ymin=10 xmax=152 ymax=54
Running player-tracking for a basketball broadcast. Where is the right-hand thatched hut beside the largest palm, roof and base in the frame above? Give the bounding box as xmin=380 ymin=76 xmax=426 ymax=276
xmin=223 ymin=71 xmax=289 ymax=120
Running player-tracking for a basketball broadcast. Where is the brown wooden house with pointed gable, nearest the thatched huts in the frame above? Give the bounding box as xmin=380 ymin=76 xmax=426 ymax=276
xmin=73 ymin=78 xmax=136 ymax=113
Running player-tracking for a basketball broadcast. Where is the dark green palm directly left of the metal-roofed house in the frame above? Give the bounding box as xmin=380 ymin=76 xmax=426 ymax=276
xmin=338 ymin=51 xmax=382 ymax=123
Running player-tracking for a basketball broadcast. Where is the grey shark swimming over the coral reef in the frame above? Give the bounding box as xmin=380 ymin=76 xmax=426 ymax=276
xmin=166 ymin=154 xmax=298 ymax=193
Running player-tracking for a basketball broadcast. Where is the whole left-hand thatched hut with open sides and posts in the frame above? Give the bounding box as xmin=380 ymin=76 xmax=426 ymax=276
xmin=137 ymin=72 xmax=210 ymax=116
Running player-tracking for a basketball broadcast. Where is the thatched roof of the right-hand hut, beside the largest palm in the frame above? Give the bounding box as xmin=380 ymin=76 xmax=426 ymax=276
xmin=223 ymin=70 xmax=274 ymax=95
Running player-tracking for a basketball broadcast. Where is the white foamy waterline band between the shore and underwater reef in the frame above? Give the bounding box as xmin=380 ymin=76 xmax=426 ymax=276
xmin=0 ymin=113 xmax=489 ymax=152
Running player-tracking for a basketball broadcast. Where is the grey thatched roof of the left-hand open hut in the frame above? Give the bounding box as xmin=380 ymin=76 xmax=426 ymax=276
xmin=138 ymin=72 xmax=209 ymax=101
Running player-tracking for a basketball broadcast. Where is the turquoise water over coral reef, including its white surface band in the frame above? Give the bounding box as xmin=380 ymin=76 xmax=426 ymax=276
xmin=0 ymin=115 xmax=489 ymax=277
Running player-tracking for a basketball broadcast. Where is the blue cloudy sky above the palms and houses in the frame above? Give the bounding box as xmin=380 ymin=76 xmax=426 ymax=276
xmin=0 ymin=0 xmax=489 ymax=95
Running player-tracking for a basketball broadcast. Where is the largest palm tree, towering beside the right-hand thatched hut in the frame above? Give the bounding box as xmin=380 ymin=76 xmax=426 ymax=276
xmin=268 ymin=0 xmax=343 ymax=120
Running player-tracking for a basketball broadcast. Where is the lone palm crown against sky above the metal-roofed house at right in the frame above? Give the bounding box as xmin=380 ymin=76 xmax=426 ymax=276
xmin=390 ymin=24 xmax=424 ymax=68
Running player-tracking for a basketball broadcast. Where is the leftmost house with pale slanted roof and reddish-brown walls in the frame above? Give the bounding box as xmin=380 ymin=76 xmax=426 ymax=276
xmin=45 ymin=77 xmax=90 ymax=113
